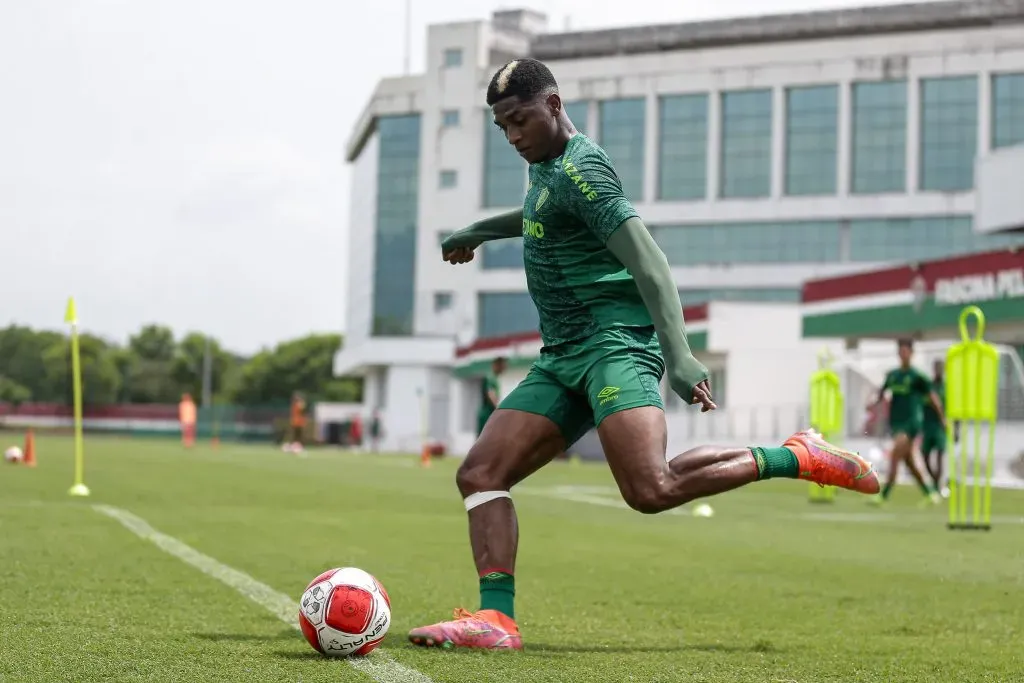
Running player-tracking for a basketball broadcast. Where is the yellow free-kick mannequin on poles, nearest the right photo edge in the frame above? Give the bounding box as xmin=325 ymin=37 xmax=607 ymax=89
xmin=943 ymin=306 xmax=999 ymax=530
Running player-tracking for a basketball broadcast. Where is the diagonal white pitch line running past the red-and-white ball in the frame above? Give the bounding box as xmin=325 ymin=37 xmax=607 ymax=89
xmin=92 ymin=505 xmax=433 ymax=683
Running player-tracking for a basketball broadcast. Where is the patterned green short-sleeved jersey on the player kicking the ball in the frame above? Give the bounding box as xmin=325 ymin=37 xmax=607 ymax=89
xmin=522 ymin=133 xmax=653 ymax=346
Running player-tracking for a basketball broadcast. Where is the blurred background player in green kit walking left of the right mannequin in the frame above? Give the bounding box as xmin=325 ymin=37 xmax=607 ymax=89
xmin=872 ymin=339 xmax=946 ymax=504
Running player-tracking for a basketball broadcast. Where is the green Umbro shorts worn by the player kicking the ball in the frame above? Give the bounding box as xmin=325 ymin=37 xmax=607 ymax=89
xmin=500 ymin=327 xmax=665 ymax=445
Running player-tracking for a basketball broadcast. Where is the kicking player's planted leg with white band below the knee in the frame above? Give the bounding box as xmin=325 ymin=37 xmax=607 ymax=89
xmin=409 ymin=369 xmax=593 ymax=649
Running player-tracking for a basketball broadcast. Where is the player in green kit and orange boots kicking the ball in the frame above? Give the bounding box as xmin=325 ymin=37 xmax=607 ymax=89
xmin=409 ymin=58 xmax=879 ymax=649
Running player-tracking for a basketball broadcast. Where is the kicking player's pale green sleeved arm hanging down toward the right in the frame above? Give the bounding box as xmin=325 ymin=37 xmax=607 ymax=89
xmin=606 ymin=216 xmax=715 ymax=411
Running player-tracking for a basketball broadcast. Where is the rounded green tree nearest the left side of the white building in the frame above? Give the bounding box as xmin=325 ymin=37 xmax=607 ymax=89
xmin=234 ymin=334 xmax=362 ymax=405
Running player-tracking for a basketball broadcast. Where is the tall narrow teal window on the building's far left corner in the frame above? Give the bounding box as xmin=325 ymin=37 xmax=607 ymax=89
xmin=372 ymin=114 xmax=420 ymax=336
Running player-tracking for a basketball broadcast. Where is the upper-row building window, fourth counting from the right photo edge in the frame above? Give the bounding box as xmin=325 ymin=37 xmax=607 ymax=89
xmin=784 ymin=85 xmax=839 ymax=196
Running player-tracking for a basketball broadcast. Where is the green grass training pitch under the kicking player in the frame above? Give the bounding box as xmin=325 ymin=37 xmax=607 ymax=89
xmin=0 ymin=433 xmax=1024 ymax=683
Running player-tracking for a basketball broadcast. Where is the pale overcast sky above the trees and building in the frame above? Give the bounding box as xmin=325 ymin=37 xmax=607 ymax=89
xmin=0 ymin=0 xmax=925 ymax=353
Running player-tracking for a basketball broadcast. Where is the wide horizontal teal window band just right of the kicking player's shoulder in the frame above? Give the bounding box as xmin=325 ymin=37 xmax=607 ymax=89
xmin=650 ymin=220 xmax=840 ymax=266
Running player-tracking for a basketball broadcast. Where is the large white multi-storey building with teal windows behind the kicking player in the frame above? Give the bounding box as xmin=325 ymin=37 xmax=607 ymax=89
xmin=335 ymin=0 xmax=1024 ymax=451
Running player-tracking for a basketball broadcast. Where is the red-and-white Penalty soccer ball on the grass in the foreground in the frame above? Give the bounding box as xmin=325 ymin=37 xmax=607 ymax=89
xmin=299 ymin=567 xmax=391 ymax=657
